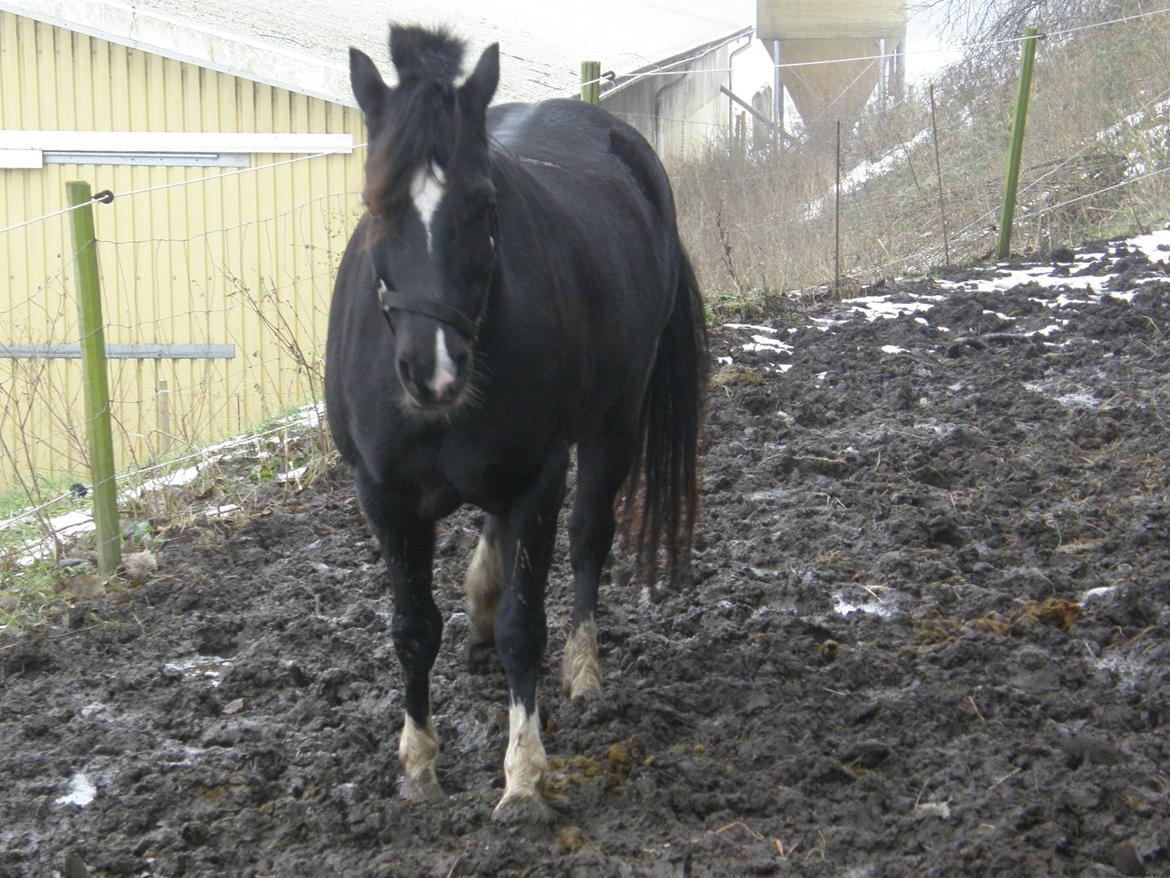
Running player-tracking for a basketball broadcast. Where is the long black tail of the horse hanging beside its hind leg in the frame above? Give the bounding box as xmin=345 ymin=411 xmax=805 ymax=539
xmin=625 ymin=250 xmax=708 ymax=585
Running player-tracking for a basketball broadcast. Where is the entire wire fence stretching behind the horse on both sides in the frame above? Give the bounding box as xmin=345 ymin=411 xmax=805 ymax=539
xmin=0 ymin=8 xmax=1170 ymax=533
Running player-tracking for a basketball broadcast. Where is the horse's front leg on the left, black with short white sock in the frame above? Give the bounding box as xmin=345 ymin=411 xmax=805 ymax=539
xmin=357 ymin=475 xmax=443 ymax=802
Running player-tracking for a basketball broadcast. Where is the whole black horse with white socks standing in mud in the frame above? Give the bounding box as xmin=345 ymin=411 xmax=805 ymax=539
xmin=325 ymin=27 xmax=707 ymax=819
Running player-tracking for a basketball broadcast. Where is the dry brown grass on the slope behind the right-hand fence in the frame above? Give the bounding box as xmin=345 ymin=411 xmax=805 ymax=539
xmin=670 ymin=4 xmax=1170 ymax=306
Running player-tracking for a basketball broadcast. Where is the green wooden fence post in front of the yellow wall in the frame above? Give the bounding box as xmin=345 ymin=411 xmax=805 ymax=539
xmin=66 ymin=181 xmax=122 ymax=576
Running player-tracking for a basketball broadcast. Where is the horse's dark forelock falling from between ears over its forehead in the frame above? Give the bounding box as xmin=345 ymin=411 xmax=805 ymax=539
xmin=364 ymin=27 xmax=464 ymax=224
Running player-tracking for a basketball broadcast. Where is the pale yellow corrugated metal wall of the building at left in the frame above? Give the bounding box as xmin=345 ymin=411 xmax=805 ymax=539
xmin=0 ymin=13 xmax=364 ymax=489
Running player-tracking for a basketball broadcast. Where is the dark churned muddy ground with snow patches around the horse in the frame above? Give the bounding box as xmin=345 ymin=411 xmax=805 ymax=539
xmin=0 ymin=237 xmax=1170 ymax=878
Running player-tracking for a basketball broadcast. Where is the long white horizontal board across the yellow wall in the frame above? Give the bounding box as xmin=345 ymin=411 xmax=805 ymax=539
xmin=0 ymin=130 xmax=353 ymax=155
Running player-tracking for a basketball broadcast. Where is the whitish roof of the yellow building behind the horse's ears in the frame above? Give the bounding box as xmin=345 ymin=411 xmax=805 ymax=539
xmin=0 ymin=0 xmax=755 ymax=107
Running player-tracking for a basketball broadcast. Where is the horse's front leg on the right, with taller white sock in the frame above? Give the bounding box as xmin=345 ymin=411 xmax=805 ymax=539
xmin=493 ymin=448 xmax=569 ymax=822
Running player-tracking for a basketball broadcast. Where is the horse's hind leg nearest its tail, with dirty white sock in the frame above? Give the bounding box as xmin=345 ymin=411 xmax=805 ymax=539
xmin=560 ymin=421 xmax=634 ymax=698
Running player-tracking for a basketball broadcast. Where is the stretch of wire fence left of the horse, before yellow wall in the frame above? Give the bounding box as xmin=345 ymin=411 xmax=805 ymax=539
xmin=0 ymin=145 xmax=364 ymax=508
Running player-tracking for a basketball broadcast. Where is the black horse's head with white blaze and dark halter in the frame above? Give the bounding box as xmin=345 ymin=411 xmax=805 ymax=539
xmin=350 ymin=27 xmax=500 ymax=411
